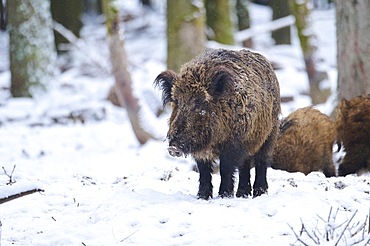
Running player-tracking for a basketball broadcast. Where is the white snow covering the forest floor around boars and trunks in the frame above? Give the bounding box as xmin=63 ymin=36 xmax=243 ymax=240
xmin=0 ymin=0 xmax=370 ymax=246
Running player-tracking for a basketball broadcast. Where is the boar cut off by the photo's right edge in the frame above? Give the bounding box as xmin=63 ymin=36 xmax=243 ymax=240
xmin=336 ymin=94 xmax=370 ymax=176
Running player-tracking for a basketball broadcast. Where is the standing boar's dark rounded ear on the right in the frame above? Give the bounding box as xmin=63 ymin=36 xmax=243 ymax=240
xmin=210 ymin=70 xmax=234 ymax=98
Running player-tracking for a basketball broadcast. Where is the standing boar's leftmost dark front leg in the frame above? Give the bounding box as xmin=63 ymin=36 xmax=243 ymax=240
xmin=196 ymin=160 xmax=213 ymax=200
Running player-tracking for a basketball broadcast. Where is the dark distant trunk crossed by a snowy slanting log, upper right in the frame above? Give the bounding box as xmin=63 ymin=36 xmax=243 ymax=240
xmin=270 ymin=0 xmax=291 ymax=44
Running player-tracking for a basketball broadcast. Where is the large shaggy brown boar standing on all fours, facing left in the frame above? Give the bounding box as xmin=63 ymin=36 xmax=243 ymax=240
xmin=155 ymin=49 xmax=280 ymax=199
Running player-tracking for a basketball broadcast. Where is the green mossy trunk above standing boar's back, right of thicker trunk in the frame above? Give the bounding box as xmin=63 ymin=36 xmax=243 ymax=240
xmin=205 ymin=0 xmax=234 ymax=44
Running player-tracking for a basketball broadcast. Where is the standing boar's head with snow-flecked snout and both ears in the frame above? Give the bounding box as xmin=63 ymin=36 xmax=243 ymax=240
xmin=154 ymin=63 xmax=233 ymax=157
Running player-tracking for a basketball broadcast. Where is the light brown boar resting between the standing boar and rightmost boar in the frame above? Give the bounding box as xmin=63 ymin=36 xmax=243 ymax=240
xmin=271 ymin=107 xmax=335 ymax=177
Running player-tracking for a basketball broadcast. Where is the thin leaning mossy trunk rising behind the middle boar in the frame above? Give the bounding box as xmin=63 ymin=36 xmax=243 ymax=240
xmin=289 ymin=0 xmax=330 ymax=104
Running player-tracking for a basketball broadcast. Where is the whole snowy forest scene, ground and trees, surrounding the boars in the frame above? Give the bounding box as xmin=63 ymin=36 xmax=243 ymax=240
xmin=0 ymin=0 xmax=370 ymax=245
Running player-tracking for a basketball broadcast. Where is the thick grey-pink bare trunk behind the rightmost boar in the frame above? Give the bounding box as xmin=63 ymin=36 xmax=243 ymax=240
xmin=336 ymin=0 xmax=370 ymax=100
